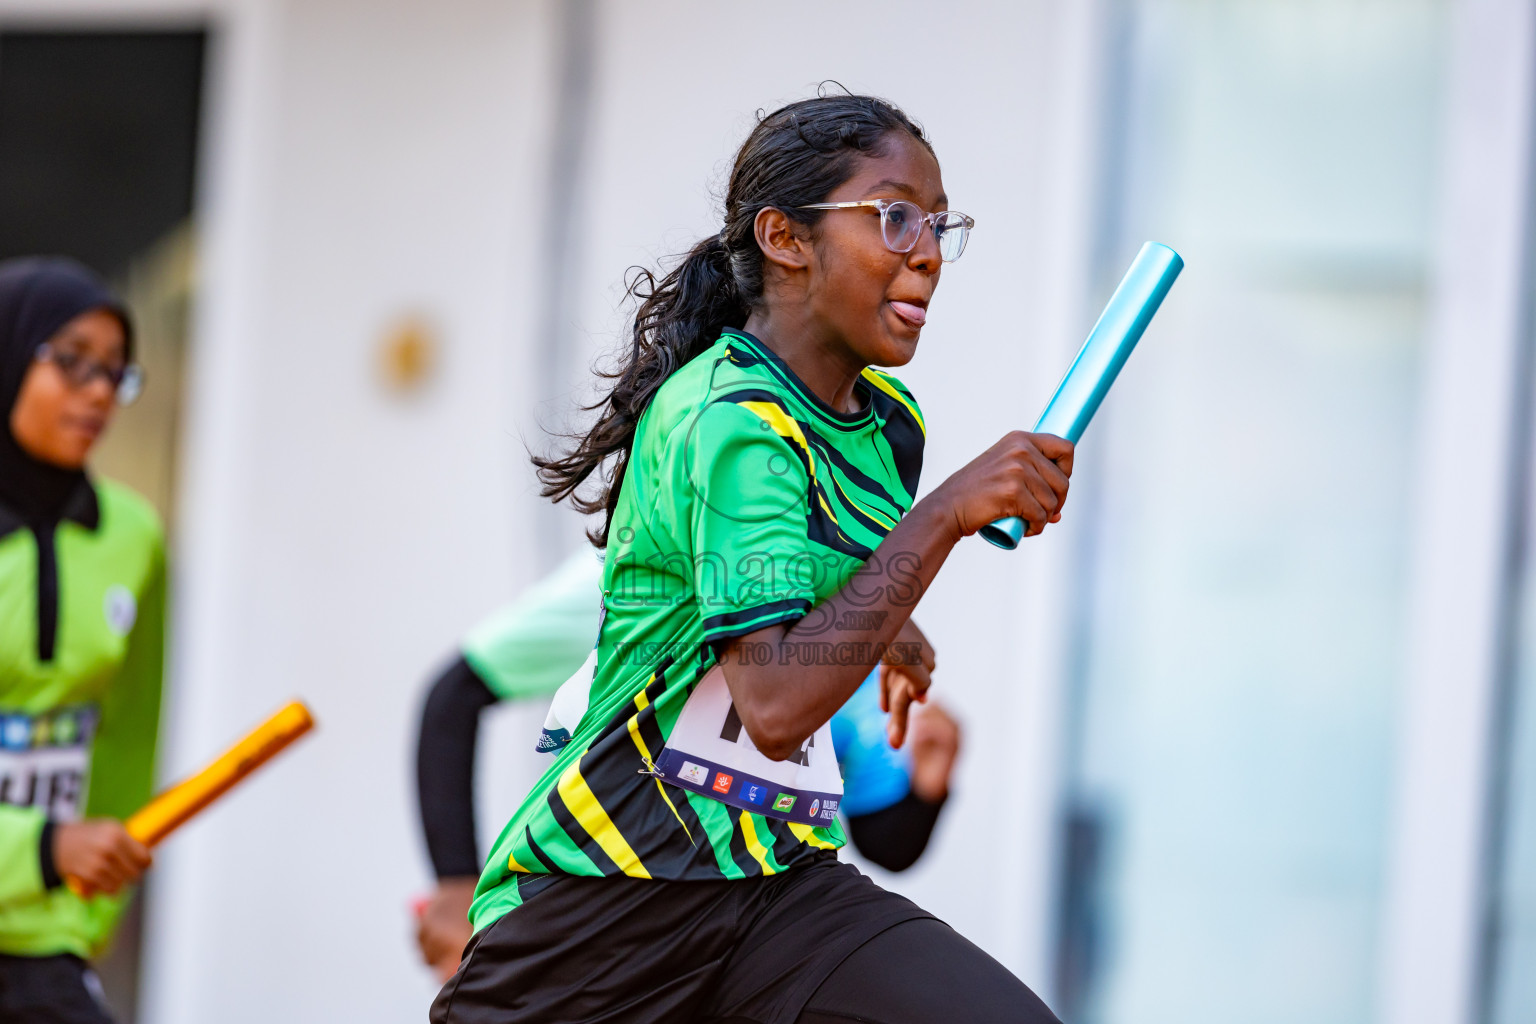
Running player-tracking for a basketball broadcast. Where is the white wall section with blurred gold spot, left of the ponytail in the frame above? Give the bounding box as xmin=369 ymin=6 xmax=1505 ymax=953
xmin=146 ymin=0 xmax=559 ymax=1022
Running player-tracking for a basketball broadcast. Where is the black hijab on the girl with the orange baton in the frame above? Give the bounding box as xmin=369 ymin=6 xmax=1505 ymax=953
xmin=0 ymin=256 xmax=134 ymax=525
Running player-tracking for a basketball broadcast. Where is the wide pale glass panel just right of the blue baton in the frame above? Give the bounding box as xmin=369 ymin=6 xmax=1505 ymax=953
xmin=1058 ymin=0 xmax=1445 ymax=1024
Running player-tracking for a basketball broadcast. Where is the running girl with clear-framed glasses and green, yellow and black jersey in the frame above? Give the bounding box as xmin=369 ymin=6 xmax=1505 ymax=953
xmin=432 ymin=95 xmax=1072 ymax=1024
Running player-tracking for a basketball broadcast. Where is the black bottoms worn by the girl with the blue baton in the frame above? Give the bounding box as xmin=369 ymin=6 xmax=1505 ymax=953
xmin=432 ymin=854 xmax=1055 ymax=1024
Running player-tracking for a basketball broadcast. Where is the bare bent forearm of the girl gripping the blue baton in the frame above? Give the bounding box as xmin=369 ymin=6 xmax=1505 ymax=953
xmin=720 ymin=491 xmax=960 ymax=760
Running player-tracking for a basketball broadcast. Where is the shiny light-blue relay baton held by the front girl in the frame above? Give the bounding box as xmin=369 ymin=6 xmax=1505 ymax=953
xmin=980 ymin=241 xmax=1184 ymax=550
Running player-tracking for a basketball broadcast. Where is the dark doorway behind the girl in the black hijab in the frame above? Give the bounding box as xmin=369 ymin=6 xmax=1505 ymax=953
xmin=0 ymin=31 xmax=207 ymax=1024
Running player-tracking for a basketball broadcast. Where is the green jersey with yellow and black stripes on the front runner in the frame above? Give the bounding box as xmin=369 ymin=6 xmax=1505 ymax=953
xmin=472 ymin=330 xmax=925 ymax=930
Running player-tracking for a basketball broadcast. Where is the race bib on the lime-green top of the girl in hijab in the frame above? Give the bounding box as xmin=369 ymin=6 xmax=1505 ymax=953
xmin=0 ymin=705 xmax=97 ymax=823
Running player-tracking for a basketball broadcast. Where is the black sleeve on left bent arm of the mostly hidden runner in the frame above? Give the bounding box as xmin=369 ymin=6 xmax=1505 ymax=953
xmin=416 ymin=657 xmax=496 ymax=878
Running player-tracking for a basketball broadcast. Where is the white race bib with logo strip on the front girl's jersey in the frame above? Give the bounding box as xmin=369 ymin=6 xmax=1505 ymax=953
xmin=656 ymin=666 xmax=843 ymax=824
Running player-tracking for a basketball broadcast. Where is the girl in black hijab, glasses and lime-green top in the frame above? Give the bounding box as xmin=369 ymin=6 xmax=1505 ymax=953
xmin=0 ymin=258 xmax=164 ymax=1024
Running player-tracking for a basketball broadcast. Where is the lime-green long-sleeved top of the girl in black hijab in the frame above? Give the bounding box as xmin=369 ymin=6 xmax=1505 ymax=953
xmin=0 ymin=481 xmax=166 ymax=956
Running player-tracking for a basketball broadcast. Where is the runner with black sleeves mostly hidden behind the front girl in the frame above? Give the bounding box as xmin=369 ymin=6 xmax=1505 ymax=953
xmin=416 ymin=548 xmax=960 ymax=981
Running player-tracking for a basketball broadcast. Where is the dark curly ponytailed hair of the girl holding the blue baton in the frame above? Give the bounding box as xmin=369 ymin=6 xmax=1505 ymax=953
xmin=533 ymin=94 xmax=932 ymax=548
